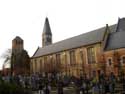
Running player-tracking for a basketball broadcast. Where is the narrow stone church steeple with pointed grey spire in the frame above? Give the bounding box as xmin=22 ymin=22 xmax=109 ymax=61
xmin=42 ymin=17 xmax=52 ymax=47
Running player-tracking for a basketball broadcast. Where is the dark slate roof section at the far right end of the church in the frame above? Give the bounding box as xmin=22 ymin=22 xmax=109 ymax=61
xmin=104 ymin=18 xmax=125 ymax=51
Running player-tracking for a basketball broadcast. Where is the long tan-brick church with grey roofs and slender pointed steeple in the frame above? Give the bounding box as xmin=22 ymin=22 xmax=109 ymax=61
xmin=30 ymin=18 xmax=125 ymax=77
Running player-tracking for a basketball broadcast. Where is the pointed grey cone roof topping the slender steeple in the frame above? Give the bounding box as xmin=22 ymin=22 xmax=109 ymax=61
xmin=43 ymin=17 xmax=52 ymax=35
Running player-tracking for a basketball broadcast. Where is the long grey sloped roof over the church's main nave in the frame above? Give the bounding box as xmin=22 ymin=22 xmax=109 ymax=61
xmin=33 ymin=25 xmax=109 ymax=57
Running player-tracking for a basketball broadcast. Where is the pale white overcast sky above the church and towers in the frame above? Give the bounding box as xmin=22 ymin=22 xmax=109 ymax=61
xmin=0 ymin=0 xmax=125 ymax=69
